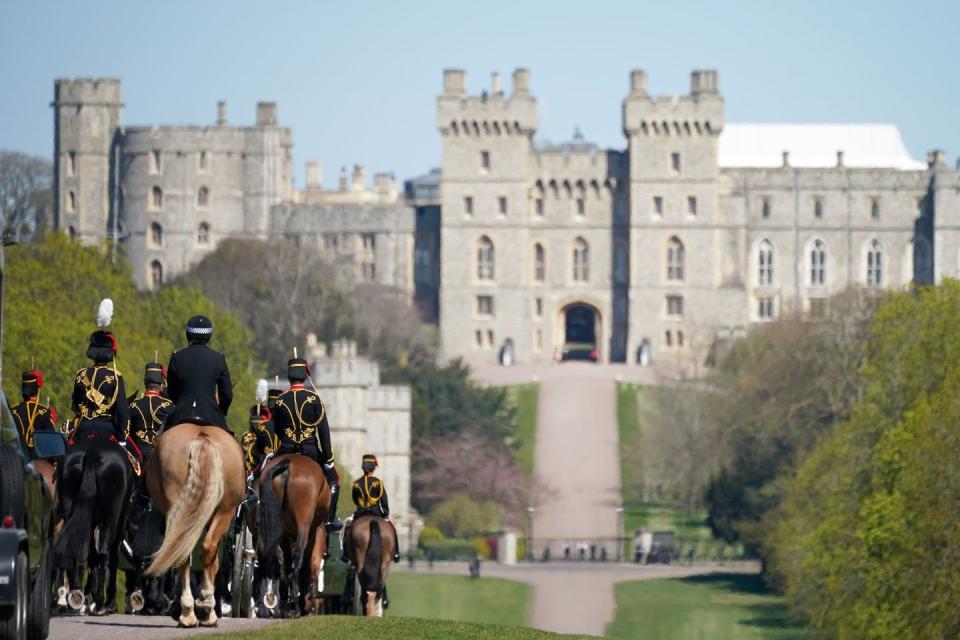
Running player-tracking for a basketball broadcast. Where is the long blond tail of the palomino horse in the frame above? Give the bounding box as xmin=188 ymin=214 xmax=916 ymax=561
xmin=147 ymin=435 xmax=223 ymax=575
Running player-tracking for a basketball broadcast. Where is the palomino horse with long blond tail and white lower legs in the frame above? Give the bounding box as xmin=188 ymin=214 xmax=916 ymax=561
xmin=146 ymin=423 xmax=246 ymax=627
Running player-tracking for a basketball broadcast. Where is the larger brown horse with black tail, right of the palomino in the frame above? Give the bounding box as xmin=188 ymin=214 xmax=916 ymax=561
xmin=257 ymin=453 xmax=330 ymax=617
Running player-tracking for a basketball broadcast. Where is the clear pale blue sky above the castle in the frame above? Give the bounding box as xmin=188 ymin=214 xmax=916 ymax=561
xmin=0 ymin=0 xmax=960 ymax=184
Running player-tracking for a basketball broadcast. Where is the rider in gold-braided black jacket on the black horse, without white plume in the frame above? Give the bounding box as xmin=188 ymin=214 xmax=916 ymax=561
xmin=69 ymin=329 xmax=130 ymax=445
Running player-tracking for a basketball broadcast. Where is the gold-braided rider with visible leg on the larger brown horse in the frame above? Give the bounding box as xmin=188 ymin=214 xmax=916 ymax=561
xmin=273 ymin=358 xmax=343 ymax=531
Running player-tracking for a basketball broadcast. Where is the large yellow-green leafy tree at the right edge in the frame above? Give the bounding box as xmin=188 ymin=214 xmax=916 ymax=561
xmin=767 ymin=281 xmax=960 ymax=639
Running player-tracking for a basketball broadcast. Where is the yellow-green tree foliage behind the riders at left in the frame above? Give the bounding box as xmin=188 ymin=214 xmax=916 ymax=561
xmin=3 ymin=234 xmax=261 ymax=431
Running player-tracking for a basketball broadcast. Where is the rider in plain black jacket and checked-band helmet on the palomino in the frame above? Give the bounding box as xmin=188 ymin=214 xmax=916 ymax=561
xmin=166 ymin=315 xmax=233 ymax=433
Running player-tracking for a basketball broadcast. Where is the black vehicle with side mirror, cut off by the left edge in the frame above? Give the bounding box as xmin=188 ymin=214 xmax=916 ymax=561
xmin=0 ymin=242 xmax=66 ymax=640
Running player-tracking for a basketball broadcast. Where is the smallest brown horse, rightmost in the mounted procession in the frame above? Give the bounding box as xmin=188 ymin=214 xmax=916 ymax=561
xmin=349 ymin=515 xmax=394 ymax=617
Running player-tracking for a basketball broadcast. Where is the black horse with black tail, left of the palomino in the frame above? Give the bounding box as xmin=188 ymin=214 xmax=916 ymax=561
xmin=55 ymin=437 xmax=136 ymax=615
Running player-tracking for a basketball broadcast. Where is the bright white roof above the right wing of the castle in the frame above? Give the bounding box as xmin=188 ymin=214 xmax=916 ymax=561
xmin=719 ymin=124 xmax=927 ymax=169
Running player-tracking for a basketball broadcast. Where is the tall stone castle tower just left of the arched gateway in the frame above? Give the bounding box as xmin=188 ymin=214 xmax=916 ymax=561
xmin=437 ymin=69 xmax=538 ymax=363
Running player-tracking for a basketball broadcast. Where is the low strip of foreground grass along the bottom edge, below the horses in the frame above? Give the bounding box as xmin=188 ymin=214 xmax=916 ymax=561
xmin=209 ymin=606 xmax=588 ymax=640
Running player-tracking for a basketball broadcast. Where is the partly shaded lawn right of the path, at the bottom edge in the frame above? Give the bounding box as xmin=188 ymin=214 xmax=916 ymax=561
xmin=606 ymin=574 xmax=815 ymax=640
